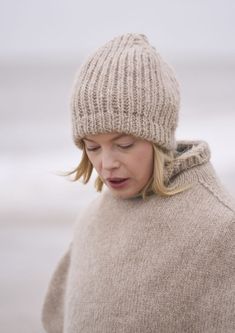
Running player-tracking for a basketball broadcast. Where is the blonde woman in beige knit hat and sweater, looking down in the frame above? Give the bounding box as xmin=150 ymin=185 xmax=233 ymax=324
xmin=42 ymin=33 xmax=235 ymax=333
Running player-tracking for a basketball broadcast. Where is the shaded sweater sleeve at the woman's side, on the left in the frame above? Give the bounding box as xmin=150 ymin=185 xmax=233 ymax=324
xmin=41 ymin=242 xmax=72 ymax=333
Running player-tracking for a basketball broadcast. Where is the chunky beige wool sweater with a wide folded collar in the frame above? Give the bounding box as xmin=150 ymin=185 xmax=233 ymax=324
xmin=42 ymin=141 xmax=235 ymax=333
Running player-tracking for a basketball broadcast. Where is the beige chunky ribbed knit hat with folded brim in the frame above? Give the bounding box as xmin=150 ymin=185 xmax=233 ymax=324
xmin=70 ymin=33 xmax=180 ymax=150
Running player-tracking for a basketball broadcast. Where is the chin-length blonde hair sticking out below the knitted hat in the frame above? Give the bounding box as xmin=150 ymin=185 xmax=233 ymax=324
xmin=63 ymin=141 xmax=191 ymax=199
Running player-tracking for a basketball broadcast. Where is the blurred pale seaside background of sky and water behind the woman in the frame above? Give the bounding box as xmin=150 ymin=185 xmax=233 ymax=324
xmin=0 ymin=0 xmax=235 ymax=333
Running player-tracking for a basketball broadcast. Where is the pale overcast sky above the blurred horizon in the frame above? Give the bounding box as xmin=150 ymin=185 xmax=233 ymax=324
xmin=0 ymin=0 xmax=235 ymax=61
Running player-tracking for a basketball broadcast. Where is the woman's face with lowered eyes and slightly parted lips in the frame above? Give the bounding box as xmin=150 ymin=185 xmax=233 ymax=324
xmin=83 ymin=133 xmax=153 ymax=199
